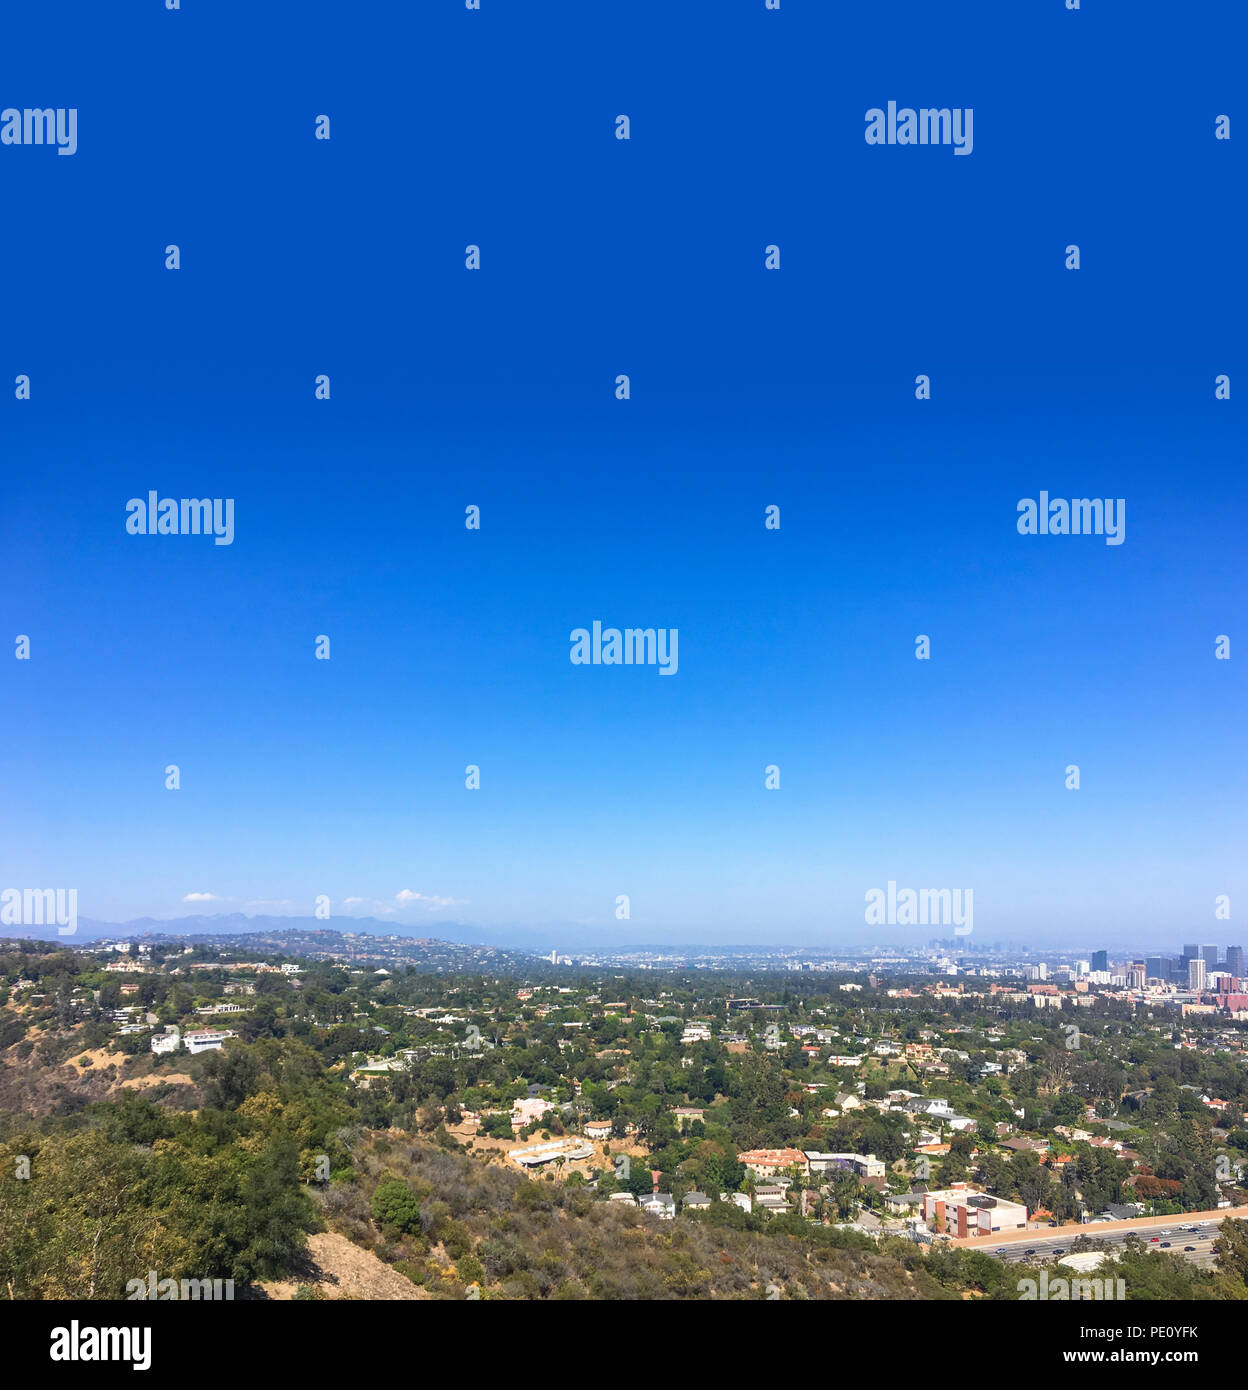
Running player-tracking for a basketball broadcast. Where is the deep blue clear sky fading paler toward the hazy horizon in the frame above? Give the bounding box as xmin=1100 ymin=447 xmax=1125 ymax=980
xmin=0 ymin=0 xmax=1248 ymax=947
